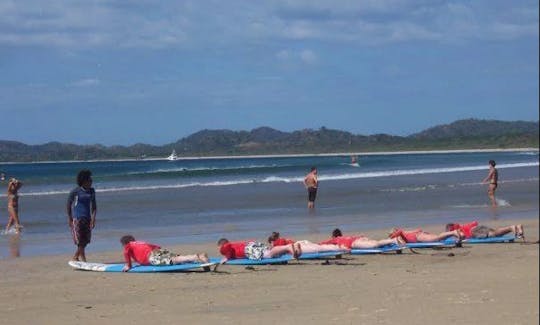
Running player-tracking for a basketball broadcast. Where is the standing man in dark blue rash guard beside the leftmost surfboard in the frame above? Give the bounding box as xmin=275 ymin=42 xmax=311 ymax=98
xmin=67 ymin=169 xmax=97 ymax=262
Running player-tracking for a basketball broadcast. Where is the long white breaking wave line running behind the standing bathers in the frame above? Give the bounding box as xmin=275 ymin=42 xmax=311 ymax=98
xmin=10 ymin=162 xmax=539 ymax=197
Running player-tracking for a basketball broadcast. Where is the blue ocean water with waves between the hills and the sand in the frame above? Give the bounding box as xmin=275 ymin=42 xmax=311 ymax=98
xmin=0 ymin=150 xmax=539 ymax=259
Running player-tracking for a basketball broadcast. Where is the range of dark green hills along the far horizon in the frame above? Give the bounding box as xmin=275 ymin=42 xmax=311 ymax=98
xmin=0 ymin=119 xmax=540 ymax=161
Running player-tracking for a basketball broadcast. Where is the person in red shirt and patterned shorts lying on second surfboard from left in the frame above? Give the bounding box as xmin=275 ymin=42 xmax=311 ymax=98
xmin=218 ymin=238 xmax=302 ymax=264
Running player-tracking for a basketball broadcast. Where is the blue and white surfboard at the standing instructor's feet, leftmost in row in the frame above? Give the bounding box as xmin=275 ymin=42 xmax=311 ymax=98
xmin=68 ymin=261 xmax=216 ymax=273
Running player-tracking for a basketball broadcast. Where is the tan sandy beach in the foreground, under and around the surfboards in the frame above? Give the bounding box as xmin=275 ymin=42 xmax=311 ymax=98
xmin=0 ymin=216 xmax=539 ymax=325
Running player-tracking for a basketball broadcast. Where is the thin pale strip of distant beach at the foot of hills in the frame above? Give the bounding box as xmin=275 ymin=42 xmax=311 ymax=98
xmin=0 ymin=148 xmax=540 ymax=165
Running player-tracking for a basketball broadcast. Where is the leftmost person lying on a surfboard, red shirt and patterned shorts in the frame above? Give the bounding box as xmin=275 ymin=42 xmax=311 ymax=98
xmin=120 ymin=235 xmax=208 ymax=272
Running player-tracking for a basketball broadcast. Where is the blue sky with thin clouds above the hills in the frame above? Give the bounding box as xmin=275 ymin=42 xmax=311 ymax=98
xmin=0 ymin=0 xmax=539 ymax=145
